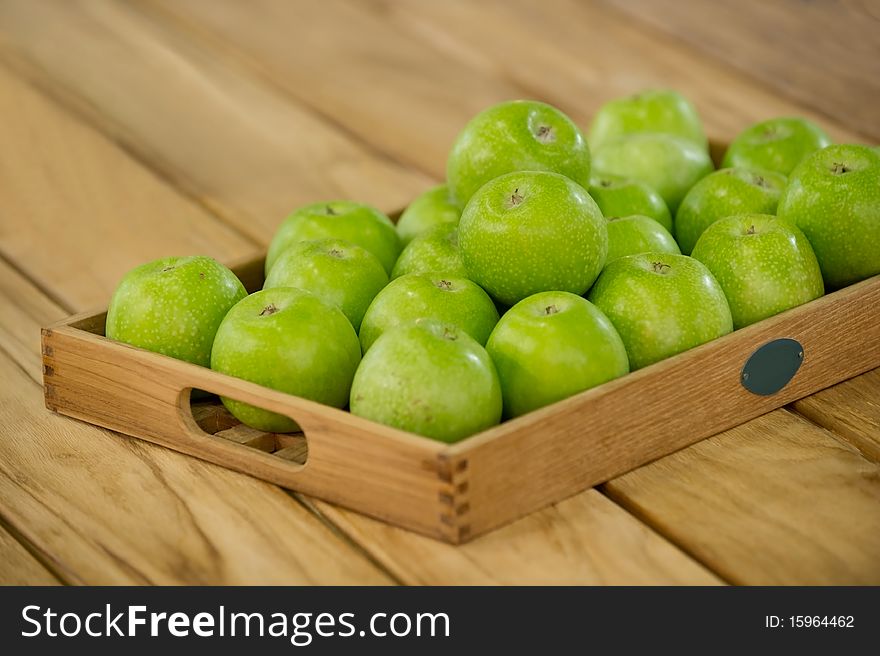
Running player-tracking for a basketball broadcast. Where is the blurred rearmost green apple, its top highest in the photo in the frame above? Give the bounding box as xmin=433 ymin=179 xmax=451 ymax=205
xmin=587 ymin=89 xmax=709 ymax=150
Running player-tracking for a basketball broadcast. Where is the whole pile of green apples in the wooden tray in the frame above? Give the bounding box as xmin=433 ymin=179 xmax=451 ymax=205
xmin=106 ymin=91 xmax=880 ymax=442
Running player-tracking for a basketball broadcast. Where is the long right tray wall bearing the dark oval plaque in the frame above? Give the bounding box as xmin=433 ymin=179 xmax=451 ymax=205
xmin=447 ymin=276 xmax=880 ymax=536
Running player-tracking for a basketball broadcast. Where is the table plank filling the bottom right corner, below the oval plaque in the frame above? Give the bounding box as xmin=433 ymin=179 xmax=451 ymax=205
xmin=605 ymin=410 xmax=880 ymax=585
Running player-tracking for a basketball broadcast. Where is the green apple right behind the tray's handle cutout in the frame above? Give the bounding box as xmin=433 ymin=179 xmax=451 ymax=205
xmin=211 ymin=287 xmax=361 ymax=433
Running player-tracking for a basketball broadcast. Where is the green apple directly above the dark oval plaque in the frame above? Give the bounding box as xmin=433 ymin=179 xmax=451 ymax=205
xmin=693 ymin=214 xmax=825 ymax=329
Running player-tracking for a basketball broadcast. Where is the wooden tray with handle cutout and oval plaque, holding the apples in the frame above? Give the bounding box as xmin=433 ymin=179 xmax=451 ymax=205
xmin=42 ymin=246 xmax=880 ymax=543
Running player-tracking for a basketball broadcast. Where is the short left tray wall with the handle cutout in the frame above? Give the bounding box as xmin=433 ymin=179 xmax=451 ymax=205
xmin=43 ymin=326 xmax=459 ymax=542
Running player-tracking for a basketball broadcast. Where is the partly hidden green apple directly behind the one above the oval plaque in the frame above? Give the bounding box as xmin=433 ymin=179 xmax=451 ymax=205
xmin=675 ymin=168 xmax=786 ymax=255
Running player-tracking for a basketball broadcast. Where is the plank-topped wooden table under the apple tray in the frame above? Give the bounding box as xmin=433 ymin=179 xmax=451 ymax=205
xmin=0 ymin=0 xmax=880 ymax=584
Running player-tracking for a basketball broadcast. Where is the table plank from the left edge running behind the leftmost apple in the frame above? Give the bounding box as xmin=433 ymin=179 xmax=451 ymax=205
xmin=0 ymin=69 xmax=256 ymax=308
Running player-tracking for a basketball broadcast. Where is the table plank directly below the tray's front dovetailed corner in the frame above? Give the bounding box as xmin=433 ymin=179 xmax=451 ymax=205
xmin=315 ymin=490 xmax=722 ymax=585
